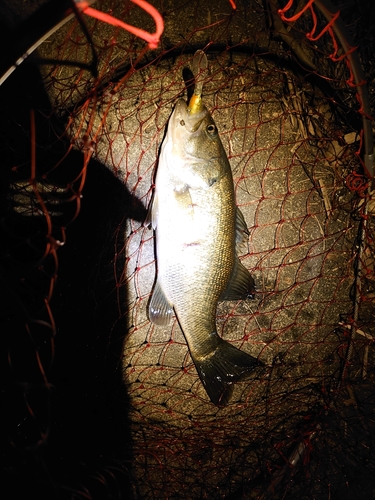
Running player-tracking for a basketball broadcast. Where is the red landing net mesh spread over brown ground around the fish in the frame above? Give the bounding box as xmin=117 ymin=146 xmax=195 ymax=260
xmin=1 ymin=0 xmax=375 ymax=499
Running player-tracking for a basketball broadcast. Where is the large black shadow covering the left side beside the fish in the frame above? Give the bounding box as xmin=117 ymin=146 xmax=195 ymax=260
xmin=0 ymin=34 xmax=146 ymax=499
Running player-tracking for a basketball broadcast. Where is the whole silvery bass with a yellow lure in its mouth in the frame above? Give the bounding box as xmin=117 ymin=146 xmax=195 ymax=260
xmin=148 ymin=51 xmax=262 ymax=406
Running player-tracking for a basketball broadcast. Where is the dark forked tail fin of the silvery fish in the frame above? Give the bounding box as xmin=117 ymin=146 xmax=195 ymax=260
xmin=192 ymin=336 xmax=263 ymax=406
